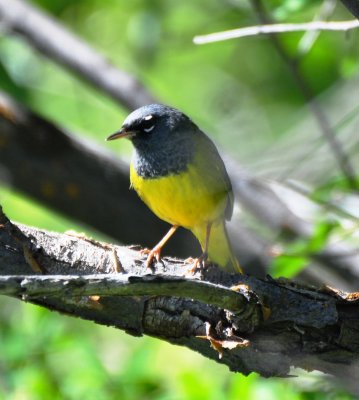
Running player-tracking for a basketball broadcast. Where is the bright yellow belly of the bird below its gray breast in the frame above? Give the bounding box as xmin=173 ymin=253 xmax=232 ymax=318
xmin=130 ymin=165 xmax=227 ymax=229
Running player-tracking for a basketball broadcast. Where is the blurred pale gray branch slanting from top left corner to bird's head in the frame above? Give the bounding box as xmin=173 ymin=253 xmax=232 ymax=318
xmin=0 ymin=0 xmax=154 ymax=109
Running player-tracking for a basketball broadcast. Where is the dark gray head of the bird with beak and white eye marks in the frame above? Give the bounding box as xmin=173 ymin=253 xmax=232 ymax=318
xmin=107 ymin=104 xmax=196 ymax=149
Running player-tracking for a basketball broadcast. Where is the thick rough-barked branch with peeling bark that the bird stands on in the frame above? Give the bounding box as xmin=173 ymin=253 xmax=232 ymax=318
xmin=0 ymin=206 xmax=359 ymax=376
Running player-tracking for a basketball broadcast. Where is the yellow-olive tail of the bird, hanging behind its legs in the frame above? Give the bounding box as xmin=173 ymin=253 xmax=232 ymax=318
xmin=192 ymin=221 xmax=243 ymax=273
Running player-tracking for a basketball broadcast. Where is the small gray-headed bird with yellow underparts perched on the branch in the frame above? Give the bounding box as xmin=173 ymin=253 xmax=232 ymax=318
xmin=107 ymin=104 xmax=242 ymax=273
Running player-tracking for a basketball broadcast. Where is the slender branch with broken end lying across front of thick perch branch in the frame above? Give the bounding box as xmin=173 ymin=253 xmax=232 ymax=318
xmin=0 ymin=274 xmax=256 ymax=312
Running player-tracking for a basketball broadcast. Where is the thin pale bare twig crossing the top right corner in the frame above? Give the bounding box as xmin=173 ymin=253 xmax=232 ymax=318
xmin=193 ymin=20 xmax=359 ymax=44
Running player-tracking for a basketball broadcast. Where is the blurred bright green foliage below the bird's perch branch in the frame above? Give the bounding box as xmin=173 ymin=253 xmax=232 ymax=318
xmin=0 ymin=299 xmax=352 ymax=400
